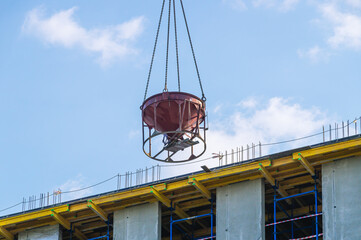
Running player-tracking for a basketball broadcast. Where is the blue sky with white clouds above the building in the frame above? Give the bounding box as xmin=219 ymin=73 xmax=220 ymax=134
xmin=0 ymin=0 xmax=361 ymax=215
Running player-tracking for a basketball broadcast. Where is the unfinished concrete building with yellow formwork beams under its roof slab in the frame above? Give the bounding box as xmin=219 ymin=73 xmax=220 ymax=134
xmin=0 ymin=135 xmax=361 ymax=240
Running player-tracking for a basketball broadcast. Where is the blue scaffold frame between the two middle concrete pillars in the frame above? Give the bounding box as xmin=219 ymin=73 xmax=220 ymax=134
xmin=169 ymin=197 xmax=216 ymax=240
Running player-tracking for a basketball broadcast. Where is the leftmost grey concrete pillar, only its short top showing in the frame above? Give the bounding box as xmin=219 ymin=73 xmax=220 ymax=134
xmin=18 ymin=224 xmax=63 ymax=240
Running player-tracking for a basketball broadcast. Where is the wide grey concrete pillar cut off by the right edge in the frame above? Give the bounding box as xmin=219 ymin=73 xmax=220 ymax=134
xmin=322 ymin=157 xmax=361 ymax=240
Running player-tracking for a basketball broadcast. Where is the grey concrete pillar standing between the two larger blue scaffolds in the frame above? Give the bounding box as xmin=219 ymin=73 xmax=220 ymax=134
xmin=217 ymin=179 xmax=265 ymax=240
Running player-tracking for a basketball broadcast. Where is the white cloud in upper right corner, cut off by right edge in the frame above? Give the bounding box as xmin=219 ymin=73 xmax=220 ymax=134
xmin=319 ymin=1 xmax=361 ymax=50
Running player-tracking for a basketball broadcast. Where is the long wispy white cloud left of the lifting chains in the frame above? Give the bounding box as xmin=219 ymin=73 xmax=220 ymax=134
xmin=22 ymin=7 xmax=144 ymax=66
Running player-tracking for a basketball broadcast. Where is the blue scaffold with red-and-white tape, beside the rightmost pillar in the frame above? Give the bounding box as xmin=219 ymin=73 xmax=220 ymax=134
xmin=266 ymin=174 xmax=323 ymax=240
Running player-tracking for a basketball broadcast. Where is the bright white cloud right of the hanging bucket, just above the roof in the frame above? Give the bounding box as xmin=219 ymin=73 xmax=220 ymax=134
xmin=208 ymin=97 xmax=326 ymax=151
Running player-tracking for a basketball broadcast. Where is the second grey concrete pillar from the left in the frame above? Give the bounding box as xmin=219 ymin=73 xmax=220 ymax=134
xmin=113 ymin=202 xmax=161 ymax=240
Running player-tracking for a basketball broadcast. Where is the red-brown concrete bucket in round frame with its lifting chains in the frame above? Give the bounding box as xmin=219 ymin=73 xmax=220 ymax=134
xmin=141 ymin=0 xmax=207 ymax=163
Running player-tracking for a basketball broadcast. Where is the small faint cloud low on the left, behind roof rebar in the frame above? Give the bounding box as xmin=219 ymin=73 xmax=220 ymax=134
xmin=59 ymin=174 xmax=92 ymax=201
